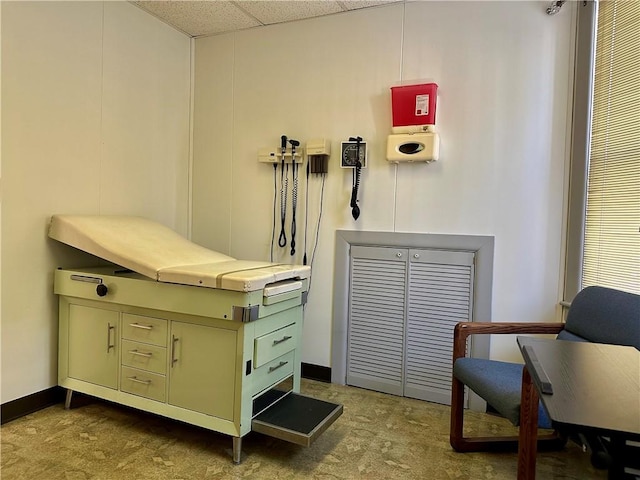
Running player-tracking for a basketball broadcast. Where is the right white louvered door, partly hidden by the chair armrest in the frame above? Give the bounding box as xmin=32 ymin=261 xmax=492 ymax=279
xmin=404 ymin=250 xmax=474 ymax=405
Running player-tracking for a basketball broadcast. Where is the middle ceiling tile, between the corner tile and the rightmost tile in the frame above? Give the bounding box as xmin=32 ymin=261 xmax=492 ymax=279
xmin=235 ymin=0 xmax=344 ymax=25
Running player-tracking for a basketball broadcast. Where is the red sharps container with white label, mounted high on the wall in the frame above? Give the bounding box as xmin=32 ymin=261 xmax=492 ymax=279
xmin=391 ymin=83 xmax=438 ymax=133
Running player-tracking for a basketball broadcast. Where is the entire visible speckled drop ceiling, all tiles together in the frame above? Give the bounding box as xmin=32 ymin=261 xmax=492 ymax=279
xmin=131 ymin=0 xmax=401 ymax=37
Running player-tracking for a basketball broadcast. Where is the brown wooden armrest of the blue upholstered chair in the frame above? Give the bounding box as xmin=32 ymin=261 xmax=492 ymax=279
xmin=453 ymin=322 xmax=564 ymax=362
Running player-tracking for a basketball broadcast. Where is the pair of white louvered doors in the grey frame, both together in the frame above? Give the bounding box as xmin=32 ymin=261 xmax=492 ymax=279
xmin=346 ymin=245 xmax=475 ymax=404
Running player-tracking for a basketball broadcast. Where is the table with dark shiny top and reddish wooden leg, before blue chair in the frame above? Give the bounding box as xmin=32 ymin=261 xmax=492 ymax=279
xmin=517 ymin=336 xmax=640 ymax=480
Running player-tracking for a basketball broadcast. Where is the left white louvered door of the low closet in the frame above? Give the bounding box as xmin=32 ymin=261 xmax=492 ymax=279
xmin=347 ymin=246 xmax=408 ymax=395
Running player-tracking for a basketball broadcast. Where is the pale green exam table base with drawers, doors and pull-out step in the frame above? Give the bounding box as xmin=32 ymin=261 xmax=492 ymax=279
xmin=55 ymin=268 xmax=342 ymax=463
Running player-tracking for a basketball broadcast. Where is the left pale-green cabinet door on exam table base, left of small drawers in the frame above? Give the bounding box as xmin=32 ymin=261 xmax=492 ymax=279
xmin=69 ymin=305 xmax=119 ymax=388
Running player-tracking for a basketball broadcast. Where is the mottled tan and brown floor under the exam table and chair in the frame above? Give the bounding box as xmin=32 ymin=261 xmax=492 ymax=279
xmin=0 ymin=379 xmax=607 ymax=480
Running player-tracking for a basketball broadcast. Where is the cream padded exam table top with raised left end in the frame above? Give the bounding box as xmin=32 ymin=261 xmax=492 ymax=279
xmin=49 ymin=215 xmax=311 ymax=292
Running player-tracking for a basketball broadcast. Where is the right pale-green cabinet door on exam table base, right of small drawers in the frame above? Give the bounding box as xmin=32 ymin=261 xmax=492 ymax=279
xmin=169 ymin=322 xmax=241 ymax=420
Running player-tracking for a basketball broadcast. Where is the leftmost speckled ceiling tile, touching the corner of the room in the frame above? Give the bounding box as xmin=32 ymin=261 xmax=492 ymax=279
xmin=133 ymin=1 xmax=260 ymax=37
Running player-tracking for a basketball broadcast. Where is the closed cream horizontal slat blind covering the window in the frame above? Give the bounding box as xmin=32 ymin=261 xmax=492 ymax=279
xmin=582 ymin=0 xmax=640 ymax=293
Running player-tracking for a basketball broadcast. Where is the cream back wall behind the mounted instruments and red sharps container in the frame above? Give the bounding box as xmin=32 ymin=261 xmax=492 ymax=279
xmin=193 ymin=2 xmax=575 ymax=366
